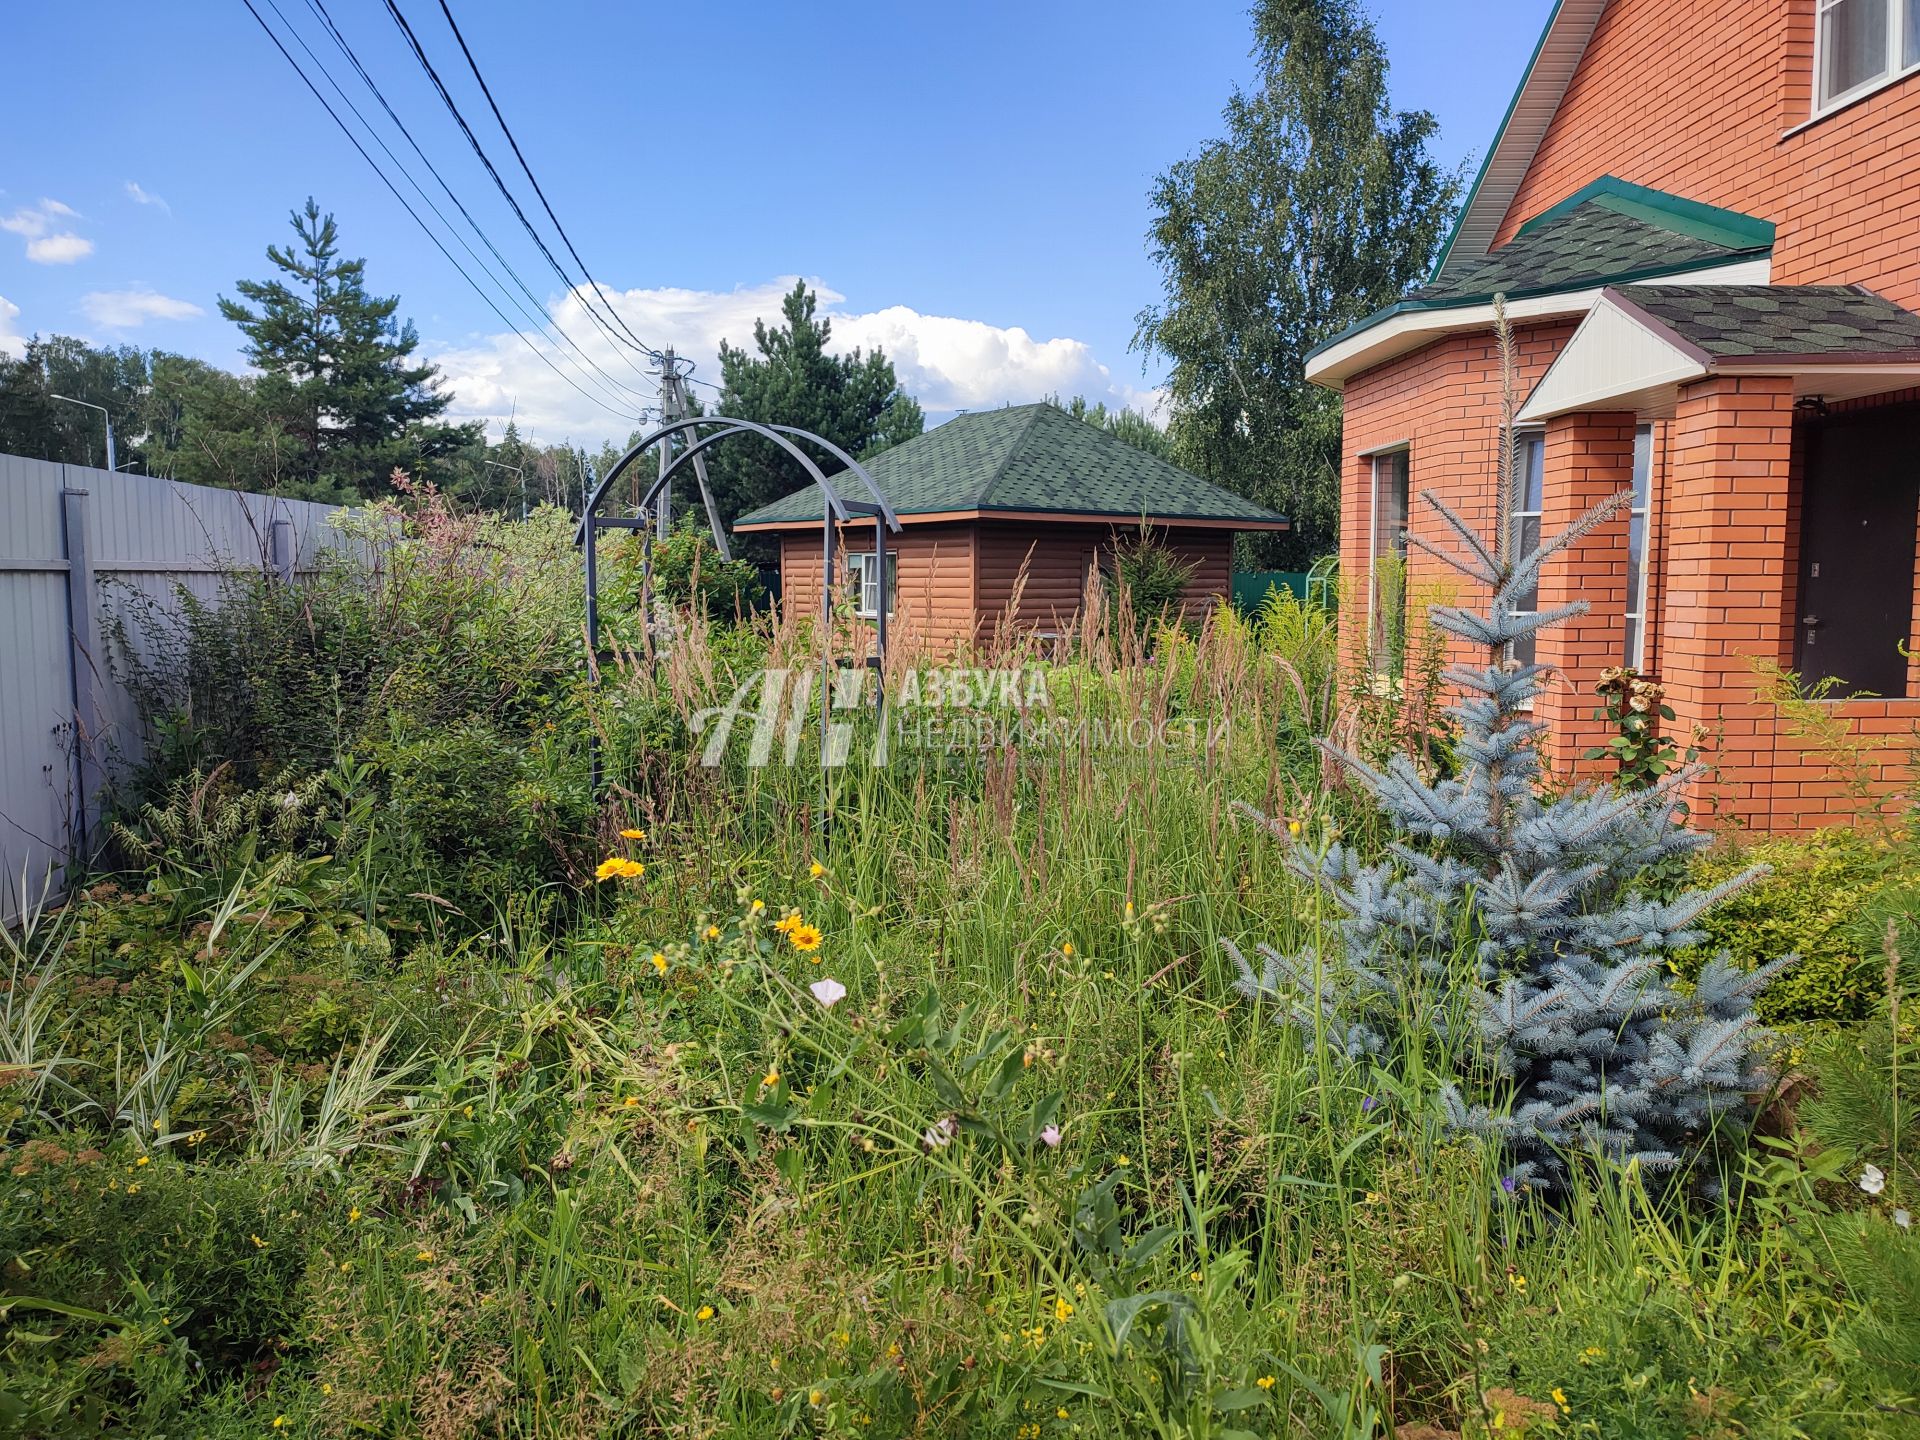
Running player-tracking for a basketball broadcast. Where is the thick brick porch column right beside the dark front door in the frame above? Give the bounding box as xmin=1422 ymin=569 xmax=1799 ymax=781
xmin=1661 ymin=376 xmax=1793 ymax=829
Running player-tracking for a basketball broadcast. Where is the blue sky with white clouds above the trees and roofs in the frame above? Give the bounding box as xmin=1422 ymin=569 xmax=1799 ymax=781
xmin=0 ymin=0 xmax=1549 ymax=442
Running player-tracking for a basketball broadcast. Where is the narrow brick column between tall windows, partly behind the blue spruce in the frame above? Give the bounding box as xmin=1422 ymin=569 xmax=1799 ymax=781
xmin=1534 ymin=411 xmax=1634 ymax=778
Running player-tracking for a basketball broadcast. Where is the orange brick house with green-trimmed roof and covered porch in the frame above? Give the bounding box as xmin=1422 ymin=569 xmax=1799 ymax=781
xmin=1308 ymin=0 xmax=1920 ymax=831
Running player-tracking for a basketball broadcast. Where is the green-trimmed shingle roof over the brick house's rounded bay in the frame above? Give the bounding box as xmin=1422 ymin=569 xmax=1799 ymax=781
xmin=1308 ymin=175 xmax=1774 ymax=359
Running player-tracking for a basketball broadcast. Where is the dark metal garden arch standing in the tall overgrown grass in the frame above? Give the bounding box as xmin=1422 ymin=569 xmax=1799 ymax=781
xmin=574 ymin=415 xmax=900 ymax=791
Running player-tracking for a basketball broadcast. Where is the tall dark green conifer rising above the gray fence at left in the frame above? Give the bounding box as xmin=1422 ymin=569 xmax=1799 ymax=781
xmin=221 ymin=198 xmax=480 ymax=495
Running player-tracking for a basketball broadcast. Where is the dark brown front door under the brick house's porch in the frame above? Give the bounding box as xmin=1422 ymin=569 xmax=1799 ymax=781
xmin=1793 ymin=407 xmax=1920 ymax=695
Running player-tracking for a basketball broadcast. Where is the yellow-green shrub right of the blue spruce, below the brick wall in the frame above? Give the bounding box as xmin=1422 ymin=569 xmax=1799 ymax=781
xmin=1680 ymin=829 xmax=1897 ymax=1025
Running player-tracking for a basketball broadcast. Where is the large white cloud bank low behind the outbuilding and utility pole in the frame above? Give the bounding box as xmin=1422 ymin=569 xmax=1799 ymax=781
xmin=428 ymin=275 xmax=1164 ymax=444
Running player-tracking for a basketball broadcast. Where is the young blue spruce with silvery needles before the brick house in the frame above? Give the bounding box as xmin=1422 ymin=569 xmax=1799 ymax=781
xmin=1227 ymin=305 xmax=1793 ymax=1190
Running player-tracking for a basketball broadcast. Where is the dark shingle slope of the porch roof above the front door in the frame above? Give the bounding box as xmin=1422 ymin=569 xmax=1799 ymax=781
xmin=1615 ymin=284 xmax=1920 ymax=359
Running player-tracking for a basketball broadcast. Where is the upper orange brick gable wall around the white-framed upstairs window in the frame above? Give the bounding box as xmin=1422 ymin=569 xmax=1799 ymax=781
xmin=1496 ymin=0 xmax=1920 ymax=309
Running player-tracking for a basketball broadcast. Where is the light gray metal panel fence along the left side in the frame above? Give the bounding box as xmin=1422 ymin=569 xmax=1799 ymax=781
xmin=0 ymin=455 xmax=357 ymax=920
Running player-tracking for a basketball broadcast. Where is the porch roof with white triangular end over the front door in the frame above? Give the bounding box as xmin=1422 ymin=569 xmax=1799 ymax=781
xmin=1519 ymin=284 xmax=1920 ymax=420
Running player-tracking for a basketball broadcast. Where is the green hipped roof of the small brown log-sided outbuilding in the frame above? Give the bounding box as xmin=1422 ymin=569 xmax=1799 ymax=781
xmin=733 ymin=403 xmax=1283 ymax=528
